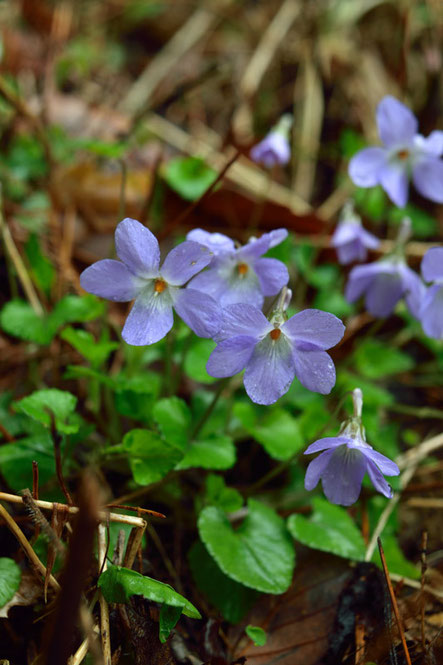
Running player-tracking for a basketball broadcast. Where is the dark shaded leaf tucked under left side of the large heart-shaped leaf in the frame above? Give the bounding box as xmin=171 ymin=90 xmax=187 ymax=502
xmin=189 ymin=540 xmax=259 ymax=624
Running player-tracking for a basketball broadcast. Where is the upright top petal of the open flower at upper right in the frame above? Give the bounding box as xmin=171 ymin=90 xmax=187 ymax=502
xmin=376 ymin=95 xmax=418 ymax=147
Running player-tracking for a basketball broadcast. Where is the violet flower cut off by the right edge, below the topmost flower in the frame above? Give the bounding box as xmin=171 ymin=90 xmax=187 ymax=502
xmin=420 ymin=247 xmax=443 ymax=339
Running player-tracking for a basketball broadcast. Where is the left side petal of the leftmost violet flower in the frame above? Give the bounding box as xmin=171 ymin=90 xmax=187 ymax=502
xmin=80 ymin=259 xmax=140 ymax=302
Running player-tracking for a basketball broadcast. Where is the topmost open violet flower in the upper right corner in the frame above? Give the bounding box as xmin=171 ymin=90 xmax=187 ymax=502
xmin=349 ymin=95 xmax=443 ymax=208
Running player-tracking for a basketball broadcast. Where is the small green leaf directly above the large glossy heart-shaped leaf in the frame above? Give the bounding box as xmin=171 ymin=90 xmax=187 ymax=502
xmin=176 ymin=434 xmax=236 ymax=470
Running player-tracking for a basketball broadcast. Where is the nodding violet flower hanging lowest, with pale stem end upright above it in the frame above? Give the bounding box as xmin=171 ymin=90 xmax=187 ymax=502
xmin=304 ymin=388 xmax=400 ymax=506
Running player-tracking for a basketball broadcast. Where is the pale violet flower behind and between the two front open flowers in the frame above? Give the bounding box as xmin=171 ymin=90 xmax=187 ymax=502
xmin=188 ymin=229 xmax=289 ymax=307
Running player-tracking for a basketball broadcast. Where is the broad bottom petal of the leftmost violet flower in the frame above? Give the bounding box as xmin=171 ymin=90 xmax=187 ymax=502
xmin=122 ymin=285 xmax=174 ymax=346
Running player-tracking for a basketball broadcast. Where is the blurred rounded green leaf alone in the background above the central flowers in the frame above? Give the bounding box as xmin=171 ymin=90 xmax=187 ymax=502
xmin=164 ymin=157 xmax=217 ymax=201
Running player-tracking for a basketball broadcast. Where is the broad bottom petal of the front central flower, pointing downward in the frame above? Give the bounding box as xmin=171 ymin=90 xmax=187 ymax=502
xmin=244 ymin=335 xmax=295 ymax=404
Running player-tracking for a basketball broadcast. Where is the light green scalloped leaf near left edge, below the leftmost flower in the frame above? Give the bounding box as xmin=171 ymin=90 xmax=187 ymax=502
xmin=13 ymin=388 xmax=78 ymax=434
